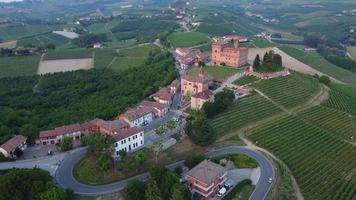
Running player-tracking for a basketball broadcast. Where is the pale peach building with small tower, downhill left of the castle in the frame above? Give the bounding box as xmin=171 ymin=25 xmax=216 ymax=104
xmin=181 ymin=67 xmax=213 ymax=96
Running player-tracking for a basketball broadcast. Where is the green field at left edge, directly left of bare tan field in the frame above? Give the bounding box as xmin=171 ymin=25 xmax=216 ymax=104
xmin=0 ymin=55 xmax=41 ymax=78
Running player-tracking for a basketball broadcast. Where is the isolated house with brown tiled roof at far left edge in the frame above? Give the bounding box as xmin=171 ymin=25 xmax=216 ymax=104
xmin=0 ymin=135 xmax=27 ymax=158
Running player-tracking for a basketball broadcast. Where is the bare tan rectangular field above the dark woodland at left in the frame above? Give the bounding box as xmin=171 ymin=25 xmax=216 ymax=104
xmin=37 ymin=58 xmax=94 ymax=74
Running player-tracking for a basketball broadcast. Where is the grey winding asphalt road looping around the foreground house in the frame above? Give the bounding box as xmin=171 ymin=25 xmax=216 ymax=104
xmin=55 ymin=146 xmax=274 ymax=200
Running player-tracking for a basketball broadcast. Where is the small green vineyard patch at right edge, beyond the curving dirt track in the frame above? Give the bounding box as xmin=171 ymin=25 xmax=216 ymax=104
xmin=323 ymin=90 xmax=356 ymax=115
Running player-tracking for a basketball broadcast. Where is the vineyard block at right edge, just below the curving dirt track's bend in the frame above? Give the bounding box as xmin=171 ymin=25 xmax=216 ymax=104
xmin=300 ymin=106 xmax=356 ymax=142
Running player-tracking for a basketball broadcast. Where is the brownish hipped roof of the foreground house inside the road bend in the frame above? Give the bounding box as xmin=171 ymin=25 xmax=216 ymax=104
xmin=187 ymin=160 xmax=226 ymax=185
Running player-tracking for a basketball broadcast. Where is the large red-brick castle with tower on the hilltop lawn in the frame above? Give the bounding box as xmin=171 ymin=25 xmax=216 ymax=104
xmin=211 ymin=36 xmax=248 ymax=67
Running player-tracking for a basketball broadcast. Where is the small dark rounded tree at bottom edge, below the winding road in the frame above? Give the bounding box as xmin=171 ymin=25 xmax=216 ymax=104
xmin=123 ymin=179 xmax=146 ymax=200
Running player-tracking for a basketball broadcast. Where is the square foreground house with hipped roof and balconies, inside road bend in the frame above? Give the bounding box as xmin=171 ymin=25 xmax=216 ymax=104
xmin=186 ymin=160 xmax=227 ymax=200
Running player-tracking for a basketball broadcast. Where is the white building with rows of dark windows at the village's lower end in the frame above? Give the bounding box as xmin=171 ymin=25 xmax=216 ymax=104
xmin=113 ymin=128 xmax=145 ymax=157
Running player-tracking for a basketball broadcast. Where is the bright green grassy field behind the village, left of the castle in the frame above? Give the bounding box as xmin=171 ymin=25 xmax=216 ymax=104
xmin=168 ymin=32 xmax=210 ymax=47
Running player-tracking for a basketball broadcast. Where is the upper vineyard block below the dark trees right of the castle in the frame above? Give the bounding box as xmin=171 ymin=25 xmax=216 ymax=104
xmin=253 ymin=72 xmax=320 ymax=108
